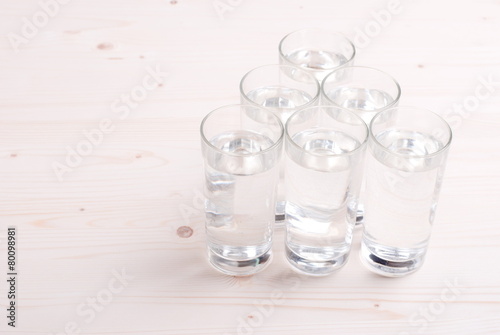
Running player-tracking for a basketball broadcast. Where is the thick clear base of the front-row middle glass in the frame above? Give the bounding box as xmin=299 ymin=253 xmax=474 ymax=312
xmin=285 ymin=246 xmax=349 ymax=277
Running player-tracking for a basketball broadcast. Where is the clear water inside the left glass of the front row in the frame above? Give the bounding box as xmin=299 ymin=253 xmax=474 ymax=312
xmin=205 ymin=131 xmax=278 ymax=271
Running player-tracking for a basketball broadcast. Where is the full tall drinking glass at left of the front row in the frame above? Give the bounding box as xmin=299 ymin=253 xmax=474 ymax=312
xmin=200 ymin=105 xmax=283 ymax=276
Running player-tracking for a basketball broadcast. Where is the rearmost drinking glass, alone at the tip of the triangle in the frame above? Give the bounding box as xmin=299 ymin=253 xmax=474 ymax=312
xmin=278 ymin=29 xmax=356 ymax=82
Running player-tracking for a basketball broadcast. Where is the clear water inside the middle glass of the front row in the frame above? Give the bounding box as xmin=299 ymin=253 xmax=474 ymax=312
xmin=285 ymin=129 xmax=360 ymax=275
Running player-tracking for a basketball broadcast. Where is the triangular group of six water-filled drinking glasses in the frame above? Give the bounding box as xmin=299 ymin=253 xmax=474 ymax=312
xmin=200 ymin=29 xmax=452 ymax=277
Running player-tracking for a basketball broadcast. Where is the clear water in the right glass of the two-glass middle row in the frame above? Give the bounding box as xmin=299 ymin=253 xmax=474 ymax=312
xmin=326 ymin=87 xmax=394 ymax=124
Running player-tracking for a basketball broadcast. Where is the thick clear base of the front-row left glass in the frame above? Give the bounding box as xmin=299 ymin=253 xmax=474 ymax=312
xmin=208 ymin=248 xmax=273 ymax=276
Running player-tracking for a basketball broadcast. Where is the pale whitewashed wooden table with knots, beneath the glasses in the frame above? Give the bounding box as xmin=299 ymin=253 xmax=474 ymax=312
xmin=0 ymin=0 xmax=500 ymax=335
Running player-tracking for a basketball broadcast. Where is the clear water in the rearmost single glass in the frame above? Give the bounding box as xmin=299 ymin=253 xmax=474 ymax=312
xmin=286 ymin=49 xmax=348 ymax=82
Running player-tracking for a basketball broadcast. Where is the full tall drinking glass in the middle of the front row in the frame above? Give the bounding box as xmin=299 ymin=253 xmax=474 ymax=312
xmin=285 ymin=106 xmax=368 ymax=276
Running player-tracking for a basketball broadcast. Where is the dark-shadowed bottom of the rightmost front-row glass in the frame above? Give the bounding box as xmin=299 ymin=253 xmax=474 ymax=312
xmin=359 ymin=239 xmax=425 ymax=277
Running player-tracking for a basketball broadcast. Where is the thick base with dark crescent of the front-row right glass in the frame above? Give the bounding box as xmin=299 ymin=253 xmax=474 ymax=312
xmin=359 ymin=241 xmax=425 ymax=277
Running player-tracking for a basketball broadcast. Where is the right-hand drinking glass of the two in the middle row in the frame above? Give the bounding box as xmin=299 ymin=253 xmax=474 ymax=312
xmin=321 ymin=66 xmax=401 ymax=225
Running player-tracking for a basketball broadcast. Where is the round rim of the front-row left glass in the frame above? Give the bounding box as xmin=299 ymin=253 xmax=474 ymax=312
xmin=200 ymin=104 xmax=285 ymax=157
